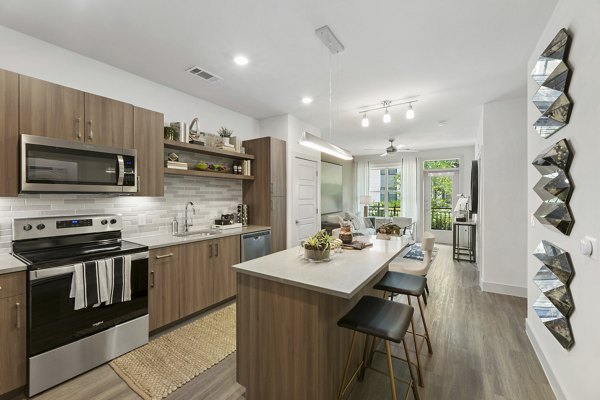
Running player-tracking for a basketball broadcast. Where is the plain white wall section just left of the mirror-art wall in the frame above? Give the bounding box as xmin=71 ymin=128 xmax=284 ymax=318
xmin=478 ymin=98 xmax=528 ymax=297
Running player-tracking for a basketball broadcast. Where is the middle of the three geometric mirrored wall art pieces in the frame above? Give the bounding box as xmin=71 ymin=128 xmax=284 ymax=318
xmin=531 ymin=139 xmax=575 ymax=235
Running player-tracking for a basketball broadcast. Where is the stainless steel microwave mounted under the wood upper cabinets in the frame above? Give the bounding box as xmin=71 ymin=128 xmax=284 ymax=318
xmin=20 ymin=134 xmax=138 ymax=193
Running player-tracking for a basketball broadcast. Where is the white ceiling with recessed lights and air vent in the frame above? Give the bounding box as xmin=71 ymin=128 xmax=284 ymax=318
xmin=0 ymin=0 xmax=556 ymax=154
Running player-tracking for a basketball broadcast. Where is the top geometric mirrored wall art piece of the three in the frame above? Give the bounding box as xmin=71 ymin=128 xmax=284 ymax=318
xmin=531 ymin=29 xmax=572 ymax=139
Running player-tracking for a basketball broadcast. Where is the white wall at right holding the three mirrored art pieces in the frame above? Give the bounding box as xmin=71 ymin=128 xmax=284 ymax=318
xmin=523 ymin=0 xmax=600 ymax=400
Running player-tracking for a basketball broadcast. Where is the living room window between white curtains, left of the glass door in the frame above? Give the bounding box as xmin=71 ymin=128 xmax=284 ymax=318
xmin=369 ymin=167 xmax=402 ymax=217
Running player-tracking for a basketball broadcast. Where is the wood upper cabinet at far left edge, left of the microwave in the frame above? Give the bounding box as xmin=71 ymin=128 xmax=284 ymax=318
xmin=0 ymin=70 xmax=19 ymax=197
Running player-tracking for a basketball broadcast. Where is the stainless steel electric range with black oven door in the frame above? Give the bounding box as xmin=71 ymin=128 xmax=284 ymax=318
xmin=13 ymin=215 xmax=148 ymax=396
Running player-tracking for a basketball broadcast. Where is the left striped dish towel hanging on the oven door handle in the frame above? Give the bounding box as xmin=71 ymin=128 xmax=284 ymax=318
xmin=69 ymin=260 xmax=108 ymax=310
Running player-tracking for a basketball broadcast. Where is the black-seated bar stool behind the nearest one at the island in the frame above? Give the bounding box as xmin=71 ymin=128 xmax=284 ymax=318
xmin=373 ymin=271 xmax=433 ymax=387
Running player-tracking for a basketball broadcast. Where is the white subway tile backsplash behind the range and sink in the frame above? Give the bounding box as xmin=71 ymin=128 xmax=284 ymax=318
xmin=0 ymin=176 xmax=242 ymax=253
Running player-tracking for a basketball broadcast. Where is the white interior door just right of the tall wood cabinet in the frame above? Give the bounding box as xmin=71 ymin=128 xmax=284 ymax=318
xmin=292 ymin=157 xmax=320 ymax=246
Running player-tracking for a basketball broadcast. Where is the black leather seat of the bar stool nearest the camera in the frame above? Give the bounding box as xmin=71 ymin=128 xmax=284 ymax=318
xmin=338 ymin=296 xmax=414 ymax=343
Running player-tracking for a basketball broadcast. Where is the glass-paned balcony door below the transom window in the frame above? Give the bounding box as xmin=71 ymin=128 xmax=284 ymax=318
xmin=423 ymin=171 xmax=458 ymax=244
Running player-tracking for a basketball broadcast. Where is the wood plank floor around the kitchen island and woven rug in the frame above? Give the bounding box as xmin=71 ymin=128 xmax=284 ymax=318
xmin=20 ymin=245 xmax=554 ymax=400
